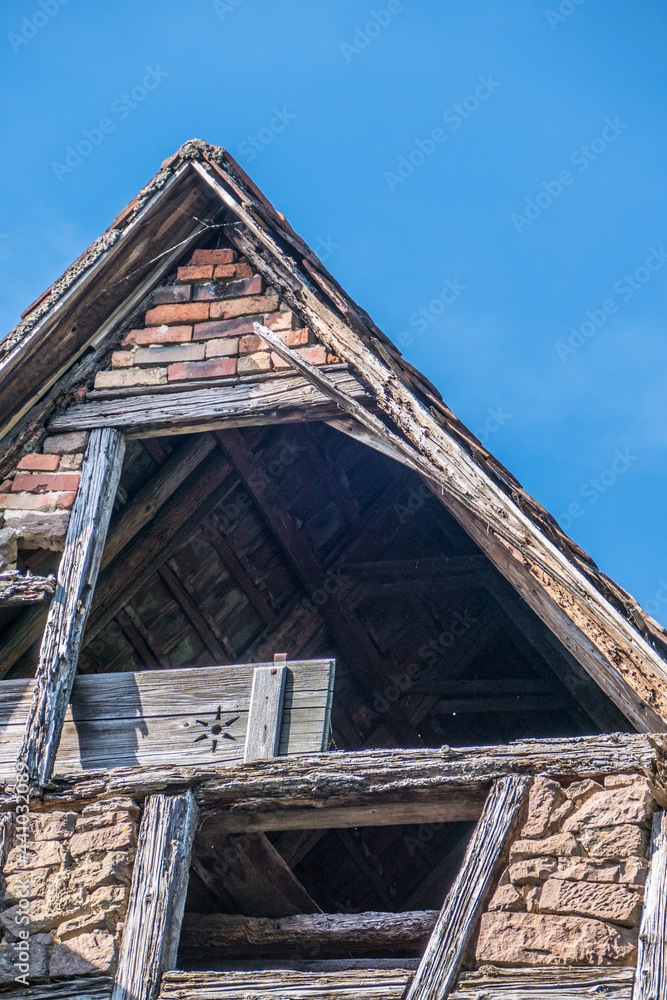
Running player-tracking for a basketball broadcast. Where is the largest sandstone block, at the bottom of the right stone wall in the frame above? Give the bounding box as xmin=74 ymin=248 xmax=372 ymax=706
xmin=477 ymin=912 xmax=637 ymax=966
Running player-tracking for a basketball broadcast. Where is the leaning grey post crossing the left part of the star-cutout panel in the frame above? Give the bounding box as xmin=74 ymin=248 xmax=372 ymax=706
xmin=19 ymin=428 xmax=125 ymax=785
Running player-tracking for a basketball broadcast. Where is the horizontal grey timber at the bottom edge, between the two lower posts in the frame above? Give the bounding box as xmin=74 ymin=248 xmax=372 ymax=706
xmin=160 ymin=969 xmax=412 ymax=1000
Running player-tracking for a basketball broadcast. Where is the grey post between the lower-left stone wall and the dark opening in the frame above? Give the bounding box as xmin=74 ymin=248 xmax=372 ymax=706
xmin=111 ymin=791 xmax=197 ymax=1000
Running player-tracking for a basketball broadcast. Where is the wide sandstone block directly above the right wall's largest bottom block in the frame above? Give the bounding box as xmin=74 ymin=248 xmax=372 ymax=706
xmin=540 ymin=879 xmax=642 ymax=927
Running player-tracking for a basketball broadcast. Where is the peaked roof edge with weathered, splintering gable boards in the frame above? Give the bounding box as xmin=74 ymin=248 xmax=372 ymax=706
xmin=0 ymin=139 xmax=667 ymax=731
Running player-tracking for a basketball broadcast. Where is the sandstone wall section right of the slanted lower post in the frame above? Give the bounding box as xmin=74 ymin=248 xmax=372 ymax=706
xmin=477 ymin=775 xmax=655 ymax=966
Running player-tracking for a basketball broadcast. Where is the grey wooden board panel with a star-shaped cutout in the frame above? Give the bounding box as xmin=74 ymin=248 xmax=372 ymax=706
xmin=0 ymin=660 xmax=335 ymax=782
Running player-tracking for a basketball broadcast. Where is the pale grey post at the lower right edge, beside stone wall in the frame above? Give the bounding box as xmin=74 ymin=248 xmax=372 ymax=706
xmin=632 ymin=812 xmax=667 ymax=1000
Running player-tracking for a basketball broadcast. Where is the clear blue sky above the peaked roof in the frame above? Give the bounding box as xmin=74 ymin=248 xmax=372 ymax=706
xmin=0 ymin=0 xmax=667 ymax=624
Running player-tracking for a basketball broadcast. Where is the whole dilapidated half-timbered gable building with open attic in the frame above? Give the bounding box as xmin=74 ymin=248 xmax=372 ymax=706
xmin=0 ymin=140 xmax=667 ymax=1000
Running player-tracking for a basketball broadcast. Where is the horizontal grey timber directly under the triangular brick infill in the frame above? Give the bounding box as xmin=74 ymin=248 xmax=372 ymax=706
xmin=49 ymin=365 xmax=369 ymax=439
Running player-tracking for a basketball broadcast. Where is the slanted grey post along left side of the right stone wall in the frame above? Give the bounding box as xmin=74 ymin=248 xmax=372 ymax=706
xmin=406 ymin=776 xmax=530 ymax=1000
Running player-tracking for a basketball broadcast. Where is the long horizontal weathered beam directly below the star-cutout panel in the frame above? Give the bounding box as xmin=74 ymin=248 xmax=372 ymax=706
xmin=10 ymin=733 xmax=667 ymax=808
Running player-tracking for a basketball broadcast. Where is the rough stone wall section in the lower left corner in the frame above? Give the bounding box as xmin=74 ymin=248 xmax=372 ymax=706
xmin=0 ymin=798 xmax=139 ymax=986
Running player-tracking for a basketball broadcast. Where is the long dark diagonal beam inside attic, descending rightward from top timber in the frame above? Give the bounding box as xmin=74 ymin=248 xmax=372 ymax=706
xmin=218 ymin=430 xmax=422 ymax=745
